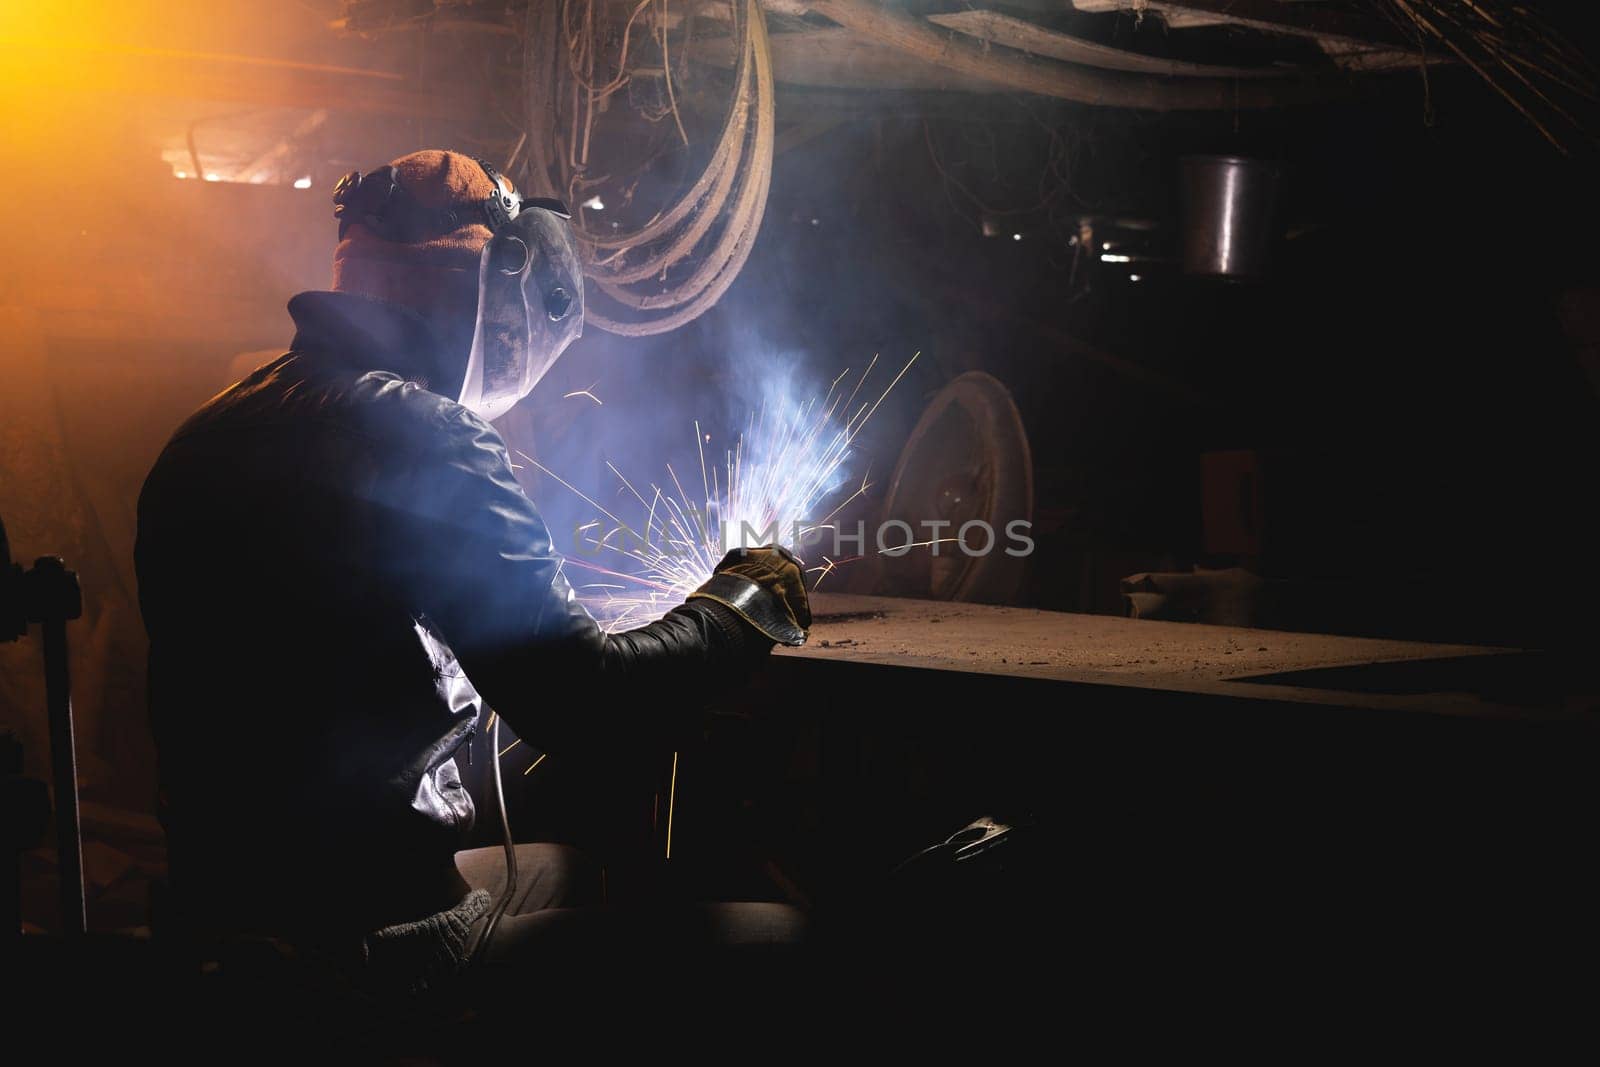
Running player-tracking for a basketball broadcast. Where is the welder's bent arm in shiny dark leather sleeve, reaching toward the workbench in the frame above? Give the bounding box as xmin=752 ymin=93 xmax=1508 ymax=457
xmin=403 ymin=404 xmax=784 ymax=752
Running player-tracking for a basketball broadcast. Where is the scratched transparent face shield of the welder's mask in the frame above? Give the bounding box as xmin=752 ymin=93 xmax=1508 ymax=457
xmin=461 ymin=206 xmax=584 ymax=419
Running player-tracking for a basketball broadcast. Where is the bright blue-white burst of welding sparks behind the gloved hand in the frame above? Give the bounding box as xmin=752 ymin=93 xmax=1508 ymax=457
xmin=518 ymin=352 xmax=922 ymax=632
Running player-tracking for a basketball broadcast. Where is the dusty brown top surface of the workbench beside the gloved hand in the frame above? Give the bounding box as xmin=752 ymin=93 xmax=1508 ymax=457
xmin=778 ymin=593 xmax=1590 ymax=718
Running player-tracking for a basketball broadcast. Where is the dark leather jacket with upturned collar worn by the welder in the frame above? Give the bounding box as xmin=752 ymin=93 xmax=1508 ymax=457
xmin=134 ymin=293 xmax=752 ymax=934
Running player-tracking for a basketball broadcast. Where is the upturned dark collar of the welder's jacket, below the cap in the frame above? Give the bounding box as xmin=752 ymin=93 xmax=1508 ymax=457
xmin=290 ymin=291 xmax=472 ymax=398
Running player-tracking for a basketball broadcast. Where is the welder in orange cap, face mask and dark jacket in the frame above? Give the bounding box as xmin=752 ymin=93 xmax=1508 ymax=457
xmin=136 ymin=150 xmax=810 ymax=990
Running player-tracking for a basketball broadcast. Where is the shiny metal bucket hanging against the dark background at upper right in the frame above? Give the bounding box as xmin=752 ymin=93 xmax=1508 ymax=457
xmin=1182 ymin=155 xmax=1288 ymax=282
